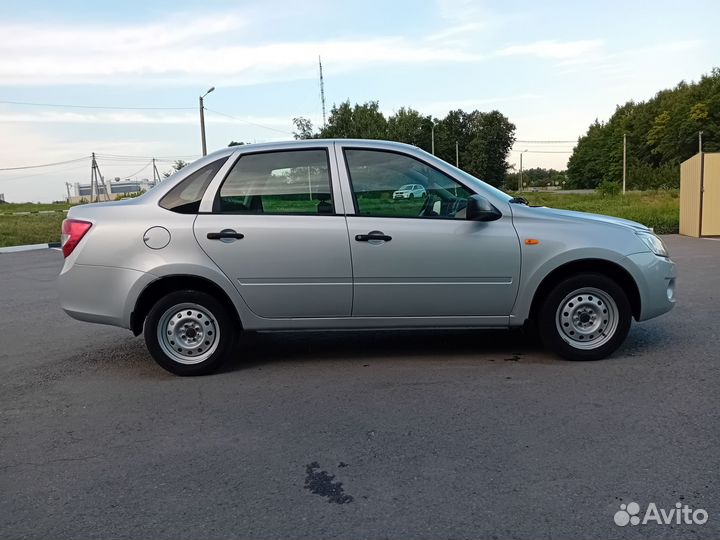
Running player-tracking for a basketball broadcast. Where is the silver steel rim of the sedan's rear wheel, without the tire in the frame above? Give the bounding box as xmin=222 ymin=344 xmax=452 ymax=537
xmin=157 ymin=303 xmax=220 ymax=365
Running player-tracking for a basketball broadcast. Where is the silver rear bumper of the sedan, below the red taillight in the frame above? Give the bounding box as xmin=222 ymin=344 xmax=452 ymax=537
xmin=58 ymin=264 xmax=156 ymax=329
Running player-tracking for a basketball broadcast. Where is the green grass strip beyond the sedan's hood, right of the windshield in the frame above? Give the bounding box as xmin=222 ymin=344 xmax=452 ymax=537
xmin=522 ymin=190 xmax=680 ymax=234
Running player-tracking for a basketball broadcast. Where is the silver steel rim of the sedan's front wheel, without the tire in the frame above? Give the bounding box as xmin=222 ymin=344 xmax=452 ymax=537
xmin=555 ymin=287 xmax=620 ymax=351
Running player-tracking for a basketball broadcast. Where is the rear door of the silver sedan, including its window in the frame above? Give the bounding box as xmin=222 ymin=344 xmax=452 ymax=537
xmin=195 ymin=145 xmax=352 ymax=318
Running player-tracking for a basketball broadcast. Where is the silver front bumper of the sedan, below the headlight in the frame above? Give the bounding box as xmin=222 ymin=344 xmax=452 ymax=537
xmin=626 ymin=252 xmax=677 ymax=321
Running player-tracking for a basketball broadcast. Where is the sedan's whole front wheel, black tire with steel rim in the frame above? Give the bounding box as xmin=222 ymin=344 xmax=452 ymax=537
xmin=537 ymin=273 xmax=632 ymax=360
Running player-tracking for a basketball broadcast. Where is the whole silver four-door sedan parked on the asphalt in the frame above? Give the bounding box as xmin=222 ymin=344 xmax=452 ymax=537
xmin=59 ymin=140 xmax=675 ymax=375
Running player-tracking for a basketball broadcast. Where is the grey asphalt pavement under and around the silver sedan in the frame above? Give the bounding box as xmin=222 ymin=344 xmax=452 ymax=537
xmin=0 ymin=236 xmax=720 ymax=540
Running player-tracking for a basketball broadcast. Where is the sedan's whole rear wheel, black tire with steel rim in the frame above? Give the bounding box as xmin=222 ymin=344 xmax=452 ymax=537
xmin=143 ymin=290 xmax=240 ymax=376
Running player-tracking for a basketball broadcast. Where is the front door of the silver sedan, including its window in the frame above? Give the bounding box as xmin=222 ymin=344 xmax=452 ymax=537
xmin=338 ymin=146 xmax=520 ymax=317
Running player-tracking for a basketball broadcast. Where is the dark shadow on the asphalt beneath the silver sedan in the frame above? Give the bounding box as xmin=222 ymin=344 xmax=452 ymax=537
xmin=58 ymin=325 xmax=664 ymax=378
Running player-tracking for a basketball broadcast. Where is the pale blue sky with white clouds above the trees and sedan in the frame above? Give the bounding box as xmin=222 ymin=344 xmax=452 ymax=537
xmin=0 ymin=0 xmax=720 ymax=202
